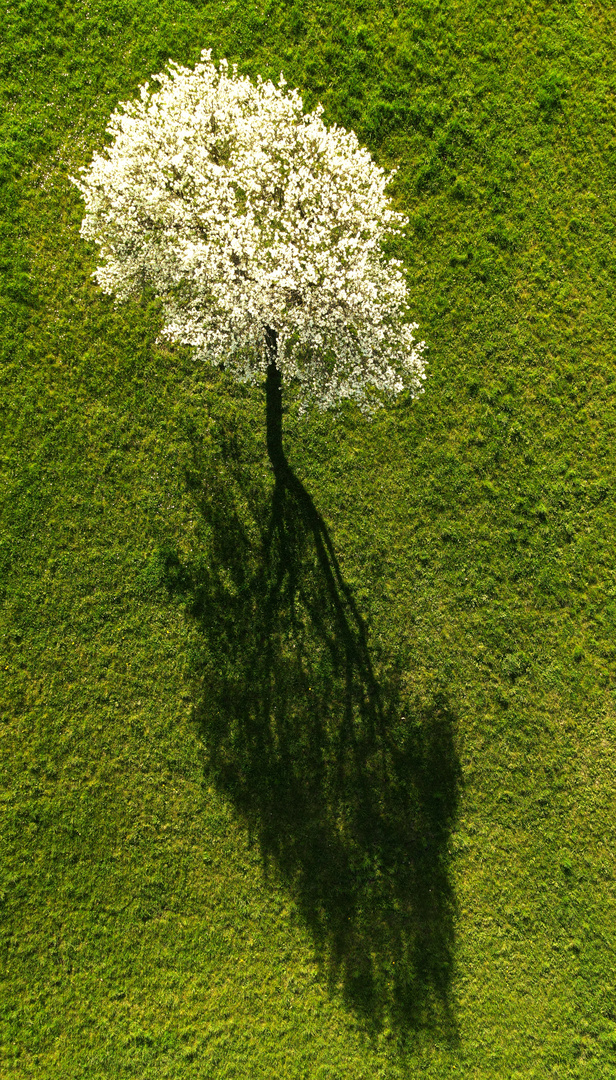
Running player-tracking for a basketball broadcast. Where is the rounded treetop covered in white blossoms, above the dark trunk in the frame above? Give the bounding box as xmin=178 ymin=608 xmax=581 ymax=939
xmin=73 ymin=51 xmax=424 ymax=408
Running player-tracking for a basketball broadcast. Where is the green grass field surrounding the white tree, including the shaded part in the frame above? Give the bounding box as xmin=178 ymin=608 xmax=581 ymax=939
xmin=0 ymin=0 xmax=616 ymax=1080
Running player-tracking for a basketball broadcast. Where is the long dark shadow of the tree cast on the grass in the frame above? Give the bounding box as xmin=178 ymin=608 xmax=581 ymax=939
xmin=175 ymin=378 xmax=459 ymax=1040
